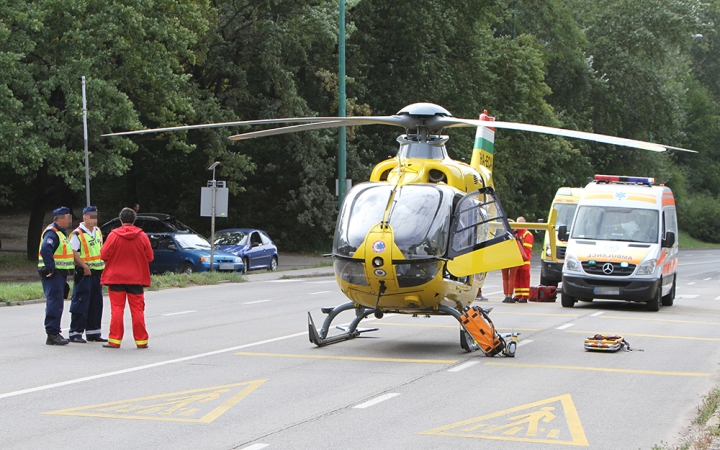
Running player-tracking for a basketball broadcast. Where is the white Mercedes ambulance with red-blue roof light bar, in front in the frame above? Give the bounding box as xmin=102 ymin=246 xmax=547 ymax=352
xmin=558 ymin=175 xmax=678 ymax=311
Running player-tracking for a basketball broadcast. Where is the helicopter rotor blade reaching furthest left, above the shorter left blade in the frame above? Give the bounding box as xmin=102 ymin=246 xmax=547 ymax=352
xmin=102 ymin=116 xmax=412 ymax=136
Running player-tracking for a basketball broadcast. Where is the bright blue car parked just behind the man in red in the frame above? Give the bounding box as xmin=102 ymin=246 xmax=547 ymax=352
xmin=148 ymin=233 xmax=245 ymax=274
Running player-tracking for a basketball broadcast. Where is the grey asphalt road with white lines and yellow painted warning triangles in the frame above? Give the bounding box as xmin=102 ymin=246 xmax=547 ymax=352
xmin=0 ymin=250 xmax=720 ymax=450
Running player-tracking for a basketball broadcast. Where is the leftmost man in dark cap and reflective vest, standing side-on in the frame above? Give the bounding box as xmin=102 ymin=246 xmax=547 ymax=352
xmin=38 ymin=206 xmax=74 ymax=345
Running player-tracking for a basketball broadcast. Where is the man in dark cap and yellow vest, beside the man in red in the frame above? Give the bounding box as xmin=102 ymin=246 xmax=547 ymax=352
xmin=68 ymin=206 xmax=107 ymax=343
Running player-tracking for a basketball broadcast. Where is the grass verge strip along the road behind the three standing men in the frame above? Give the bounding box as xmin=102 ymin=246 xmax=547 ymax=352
xmin=0 ymin=272 xmax=245 ymax=305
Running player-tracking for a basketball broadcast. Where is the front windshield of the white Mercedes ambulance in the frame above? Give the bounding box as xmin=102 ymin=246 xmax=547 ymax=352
xmin=571 ymin=206 xmax=659 ymax=244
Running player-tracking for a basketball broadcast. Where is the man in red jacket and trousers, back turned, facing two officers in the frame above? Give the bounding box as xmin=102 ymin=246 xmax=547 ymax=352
xmin=100 ymin=208 xmax=154 ymax=348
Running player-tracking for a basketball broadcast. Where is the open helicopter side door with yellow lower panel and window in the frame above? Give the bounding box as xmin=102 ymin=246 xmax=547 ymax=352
xmin=447 ymin=187 xmax=523 ymax=277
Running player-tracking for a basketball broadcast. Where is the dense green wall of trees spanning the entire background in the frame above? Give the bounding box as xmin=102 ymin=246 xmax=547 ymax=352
xmin=0 ymin=0 xmax=720 ymax=251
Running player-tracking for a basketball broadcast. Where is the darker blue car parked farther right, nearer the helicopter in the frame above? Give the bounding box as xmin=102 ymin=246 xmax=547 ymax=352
xmin=215 ymin=228 xmax=278 ymax=272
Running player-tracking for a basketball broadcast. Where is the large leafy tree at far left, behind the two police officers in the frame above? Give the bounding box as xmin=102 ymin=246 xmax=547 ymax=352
xmin=0 ymin=0 xmax=219 ymax=259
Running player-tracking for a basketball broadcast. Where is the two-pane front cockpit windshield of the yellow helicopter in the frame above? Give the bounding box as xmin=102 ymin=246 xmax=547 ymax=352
xmin=333 ymin=183 xmax=455 ymax=259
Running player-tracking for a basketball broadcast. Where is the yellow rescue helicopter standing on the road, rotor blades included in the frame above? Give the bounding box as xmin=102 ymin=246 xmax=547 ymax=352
xmin=105 ymin=103 xmax=692 ymax=351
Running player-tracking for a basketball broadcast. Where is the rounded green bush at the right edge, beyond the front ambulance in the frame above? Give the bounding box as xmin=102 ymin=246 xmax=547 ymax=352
xmin=678 ymin=194 xmax=720 ymax=243
